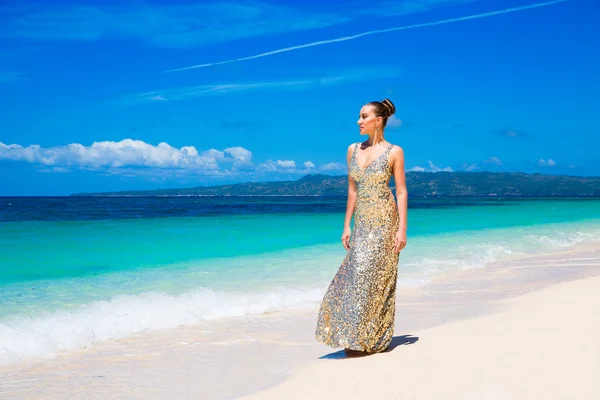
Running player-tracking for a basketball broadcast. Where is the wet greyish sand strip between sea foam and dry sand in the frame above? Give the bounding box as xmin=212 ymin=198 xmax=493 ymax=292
xmin=0 ymin=244 xmax=600 ymax=399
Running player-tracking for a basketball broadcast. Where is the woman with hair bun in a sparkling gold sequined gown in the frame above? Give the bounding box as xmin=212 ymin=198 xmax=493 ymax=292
xmin=316 ymin=99 xmax=408 ymax=353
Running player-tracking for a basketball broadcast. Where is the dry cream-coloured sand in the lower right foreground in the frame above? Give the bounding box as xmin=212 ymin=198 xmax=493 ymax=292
xmin=243 ymin=277 xmax=600 ymax=400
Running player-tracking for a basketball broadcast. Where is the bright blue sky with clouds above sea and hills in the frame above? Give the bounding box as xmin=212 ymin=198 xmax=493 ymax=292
xmin=0 ymin=0 xmax=600 ymax=195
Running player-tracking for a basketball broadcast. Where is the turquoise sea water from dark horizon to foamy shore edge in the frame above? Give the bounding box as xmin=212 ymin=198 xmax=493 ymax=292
xmin=0 ymin=197 xmax=600 ymax=364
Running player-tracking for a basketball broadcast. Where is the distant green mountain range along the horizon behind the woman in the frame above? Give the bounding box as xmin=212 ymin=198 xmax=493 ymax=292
xmin=72 ymin=172 xmax=600 ymax=197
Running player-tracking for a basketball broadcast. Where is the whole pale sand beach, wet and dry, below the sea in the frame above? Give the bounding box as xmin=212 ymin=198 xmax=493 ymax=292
xmin=0 ymin=246 xmax=600 ymax=400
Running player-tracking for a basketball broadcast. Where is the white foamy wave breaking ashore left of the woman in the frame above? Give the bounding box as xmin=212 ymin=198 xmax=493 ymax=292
xmin=0 ymin=288 xmax=323 ymax=365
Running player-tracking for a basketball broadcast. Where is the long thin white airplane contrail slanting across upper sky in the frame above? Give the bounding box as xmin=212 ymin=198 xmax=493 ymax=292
xmin=163 ymin=0 xmax=569 ymax=73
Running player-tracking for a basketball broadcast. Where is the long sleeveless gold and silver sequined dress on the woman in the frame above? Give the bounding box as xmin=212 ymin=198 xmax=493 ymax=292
xmin=315 ymin=143 xmax=399 ymax=353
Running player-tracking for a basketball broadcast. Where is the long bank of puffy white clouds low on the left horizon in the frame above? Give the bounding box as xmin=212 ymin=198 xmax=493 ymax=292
xmin=0 ymin=139 xmax=345 ymax=179
